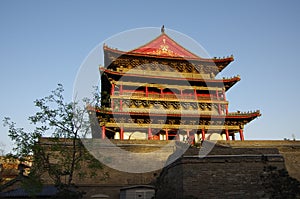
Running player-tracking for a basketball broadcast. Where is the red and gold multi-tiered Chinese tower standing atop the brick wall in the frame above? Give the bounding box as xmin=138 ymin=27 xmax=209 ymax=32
xmin=94 ymin=28 xmax=261 ymax=139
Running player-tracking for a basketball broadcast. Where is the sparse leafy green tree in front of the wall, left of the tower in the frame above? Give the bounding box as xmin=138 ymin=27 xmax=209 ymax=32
xmin=4 ymin=84 xmax=108 ymax=197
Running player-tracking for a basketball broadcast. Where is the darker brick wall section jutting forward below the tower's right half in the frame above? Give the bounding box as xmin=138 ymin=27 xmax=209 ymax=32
xmin=157 ymin=142 xmax=285 ymax=198
